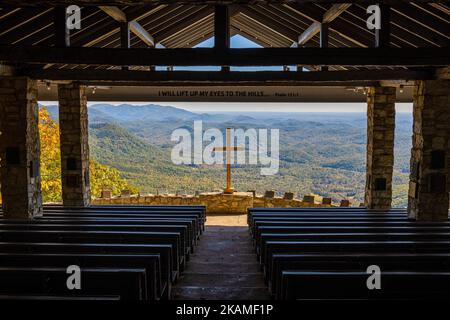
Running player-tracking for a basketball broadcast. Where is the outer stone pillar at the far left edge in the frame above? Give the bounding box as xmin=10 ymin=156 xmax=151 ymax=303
xmin=0 ymin=77 xmax=42 ymax=219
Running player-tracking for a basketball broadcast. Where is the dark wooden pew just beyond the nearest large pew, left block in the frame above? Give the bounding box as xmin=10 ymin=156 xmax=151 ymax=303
xmin=0 ymin=252 xmax=160 ymax=300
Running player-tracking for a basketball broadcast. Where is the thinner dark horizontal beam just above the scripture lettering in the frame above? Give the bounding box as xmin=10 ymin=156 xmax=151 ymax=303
xmin=21 ymin=69 xmax=436 ymax=85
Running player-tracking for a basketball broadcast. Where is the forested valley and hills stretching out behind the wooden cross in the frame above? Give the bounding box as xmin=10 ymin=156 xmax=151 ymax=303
xmin=49 ymin=104 xmax=411 ymax=206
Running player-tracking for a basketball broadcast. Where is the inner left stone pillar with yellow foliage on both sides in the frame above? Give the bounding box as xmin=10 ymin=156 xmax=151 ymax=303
xmin=58 ymin=83 xmax=91 ymax=207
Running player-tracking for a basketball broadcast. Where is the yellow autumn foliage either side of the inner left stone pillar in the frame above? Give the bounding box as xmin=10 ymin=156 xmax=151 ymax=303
xmin=39 ymin=107 xmax=138 ymax=202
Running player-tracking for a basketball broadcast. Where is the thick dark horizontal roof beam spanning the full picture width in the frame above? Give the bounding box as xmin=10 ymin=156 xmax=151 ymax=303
xmin=0 ymin=45 xmax=450 ymax=66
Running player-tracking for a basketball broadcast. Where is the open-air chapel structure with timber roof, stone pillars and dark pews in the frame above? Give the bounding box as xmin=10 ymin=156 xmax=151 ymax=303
xmin=0 ymin=0 xmax=450 ymax=299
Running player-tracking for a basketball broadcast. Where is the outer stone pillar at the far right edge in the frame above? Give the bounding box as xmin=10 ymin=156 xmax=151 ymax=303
xmin=408 ymin=80 xmax=450 ymax=221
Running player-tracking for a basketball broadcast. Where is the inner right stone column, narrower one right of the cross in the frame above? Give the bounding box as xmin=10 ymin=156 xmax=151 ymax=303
xmin=365 ymin=87 xmax=396 ymax=210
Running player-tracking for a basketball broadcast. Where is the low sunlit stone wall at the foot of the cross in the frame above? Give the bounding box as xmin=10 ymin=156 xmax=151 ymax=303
xmin=92 ymin=192 xmax=338 ymax=214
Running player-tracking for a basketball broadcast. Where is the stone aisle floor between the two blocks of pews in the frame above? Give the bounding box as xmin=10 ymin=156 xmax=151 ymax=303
xmin=173 ymin=215 xmax=269 ymax=300
